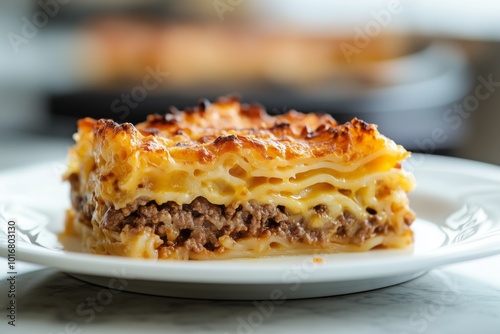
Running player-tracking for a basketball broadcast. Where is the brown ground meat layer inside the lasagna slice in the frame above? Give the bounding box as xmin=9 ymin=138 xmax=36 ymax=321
xmin=70 ymin=178 xmax=398 ymax=252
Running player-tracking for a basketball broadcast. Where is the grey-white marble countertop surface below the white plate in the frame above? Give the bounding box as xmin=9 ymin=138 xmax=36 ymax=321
xmin=0 ymin=256 xmax=500 ymax=334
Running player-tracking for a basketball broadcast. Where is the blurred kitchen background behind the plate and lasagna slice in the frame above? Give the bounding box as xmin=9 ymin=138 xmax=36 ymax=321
xmin=0 ymin=0 xmax=500 ymax=168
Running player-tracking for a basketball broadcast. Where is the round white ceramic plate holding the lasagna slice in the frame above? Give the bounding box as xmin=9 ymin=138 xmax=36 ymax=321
xmin=0 ymin=155 xmax=500 ymax=299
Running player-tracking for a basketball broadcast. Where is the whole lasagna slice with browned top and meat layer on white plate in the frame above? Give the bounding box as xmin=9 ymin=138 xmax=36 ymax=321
xmin=64 ymin=97 xmax=415 ymax=260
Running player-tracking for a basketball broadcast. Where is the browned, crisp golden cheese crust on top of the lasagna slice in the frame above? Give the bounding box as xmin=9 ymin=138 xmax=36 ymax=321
xmin=70 ymin=95 xmax=408 ymax=167
